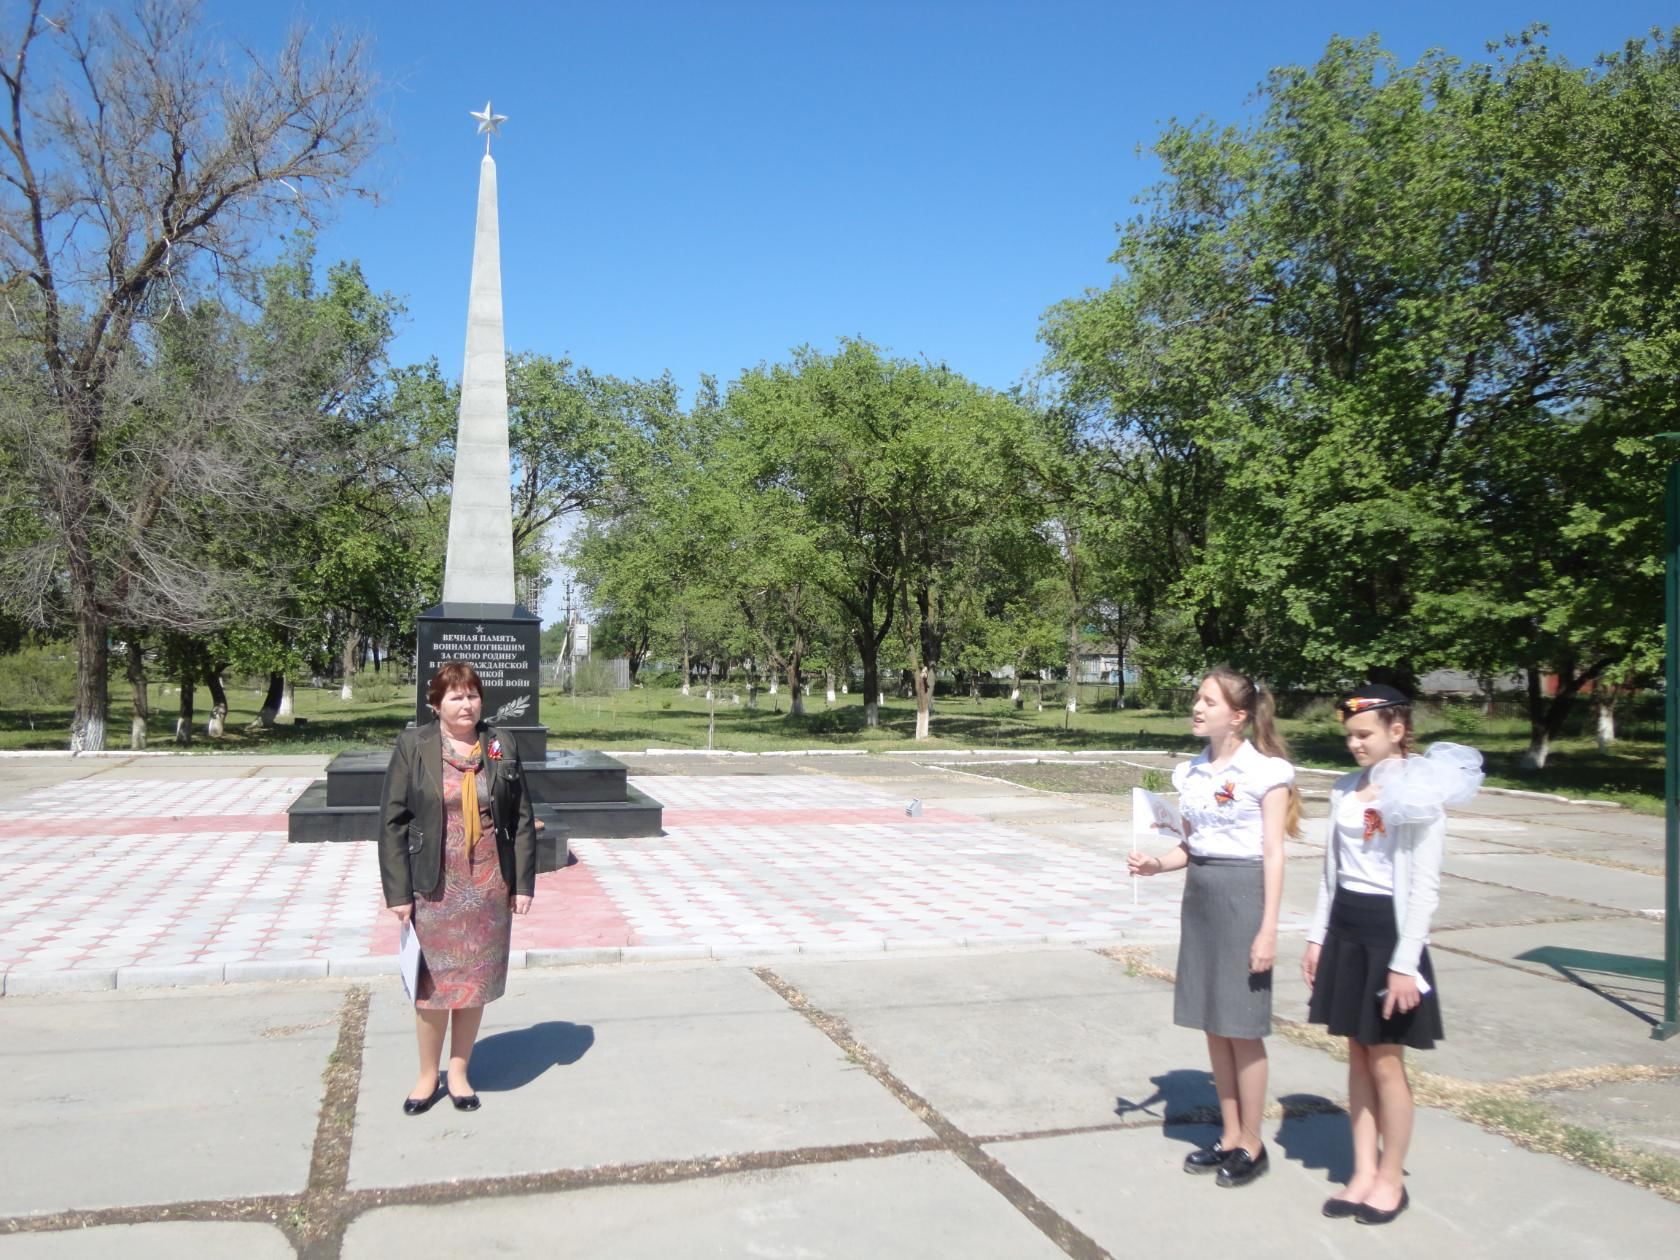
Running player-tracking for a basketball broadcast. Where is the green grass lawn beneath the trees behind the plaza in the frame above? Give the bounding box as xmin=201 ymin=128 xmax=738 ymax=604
xmin=0 ymin=682 xmax=1663 ymax=813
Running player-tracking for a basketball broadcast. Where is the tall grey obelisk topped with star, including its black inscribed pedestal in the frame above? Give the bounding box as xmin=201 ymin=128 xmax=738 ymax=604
xmin=415 ymin=101 xmax=546 ymax=761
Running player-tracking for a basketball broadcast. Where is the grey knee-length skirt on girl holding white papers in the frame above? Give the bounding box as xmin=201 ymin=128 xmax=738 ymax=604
xmin=1173 ymin=857 xmax=1272 ymax=1040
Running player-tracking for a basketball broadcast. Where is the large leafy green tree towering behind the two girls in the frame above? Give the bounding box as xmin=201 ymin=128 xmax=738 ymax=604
xmin=1045 ymin=24 xmax=1680 ymax=763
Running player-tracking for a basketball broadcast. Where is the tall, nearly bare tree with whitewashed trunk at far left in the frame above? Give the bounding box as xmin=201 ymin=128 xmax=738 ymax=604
xmin=0 ymin=0 xmax=380 ymax=749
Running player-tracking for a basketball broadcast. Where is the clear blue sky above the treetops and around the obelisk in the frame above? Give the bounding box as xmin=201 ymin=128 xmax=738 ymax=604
xmin=207 ymin=0 xmax=1680 ymax=399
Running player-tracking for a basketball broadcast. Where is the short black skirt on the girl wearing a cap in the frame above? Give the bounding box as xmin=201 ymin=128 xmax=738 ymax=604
xmin=1307 ymin=889 xmax=1445 ymax=1050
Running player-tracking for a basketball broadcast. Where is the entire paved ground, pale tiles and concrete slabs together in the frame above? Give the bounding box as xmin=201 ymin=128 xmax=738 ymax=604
xmin=0 ymin=758 xmax=1680 ymax=1260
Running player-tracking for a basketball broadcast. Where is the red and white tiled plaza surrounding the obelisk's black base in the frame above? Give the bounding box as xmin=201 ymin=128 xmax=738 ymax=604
xmin=0 ymin=759 xmax=1296 ymax=991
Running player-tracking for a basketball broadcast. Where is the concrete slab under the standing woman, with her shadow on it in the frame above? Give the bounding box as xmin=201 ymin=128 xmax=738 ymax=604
xmin=349 ymin=964 xmax=929 ymax=1188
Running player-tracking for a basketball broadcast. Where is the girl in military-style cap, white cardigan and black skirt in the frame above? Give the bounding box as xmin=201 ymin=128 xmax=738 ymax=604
xmin=1300 ymin=684 xmax=1482 ymax=1225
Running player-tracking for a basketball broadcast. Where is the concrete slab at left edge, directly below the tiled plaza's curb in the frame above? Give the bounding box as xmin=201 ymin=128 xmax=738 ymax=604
xmin=0 ymin=984 xmax=341 ymax=1216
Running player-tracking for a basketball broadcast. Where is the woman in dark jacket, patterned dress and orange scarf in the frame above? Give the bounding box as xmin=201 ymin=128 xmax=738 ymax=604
xmin=380 ymin=660 xmax=536 ymax=1116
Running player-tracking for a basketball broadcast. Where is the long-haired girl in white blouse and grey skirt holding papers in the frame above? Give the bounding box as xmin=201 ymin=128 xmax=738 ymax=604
xmin=1131 ymin=665 xmax=1300 ymax=1186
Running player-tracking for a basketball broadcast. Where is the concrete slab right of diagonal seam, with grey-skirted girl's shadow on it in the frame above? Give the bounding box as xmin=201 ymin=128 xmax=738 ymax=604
xmin=776 ymin=949 xmax=1341 ymax=1136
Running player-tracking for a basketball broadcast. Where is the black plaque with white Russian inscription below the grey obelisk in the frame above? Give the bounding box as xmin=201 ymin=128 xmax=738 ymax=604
xmin=415 ymin=603 xmax=543 ymax=726
